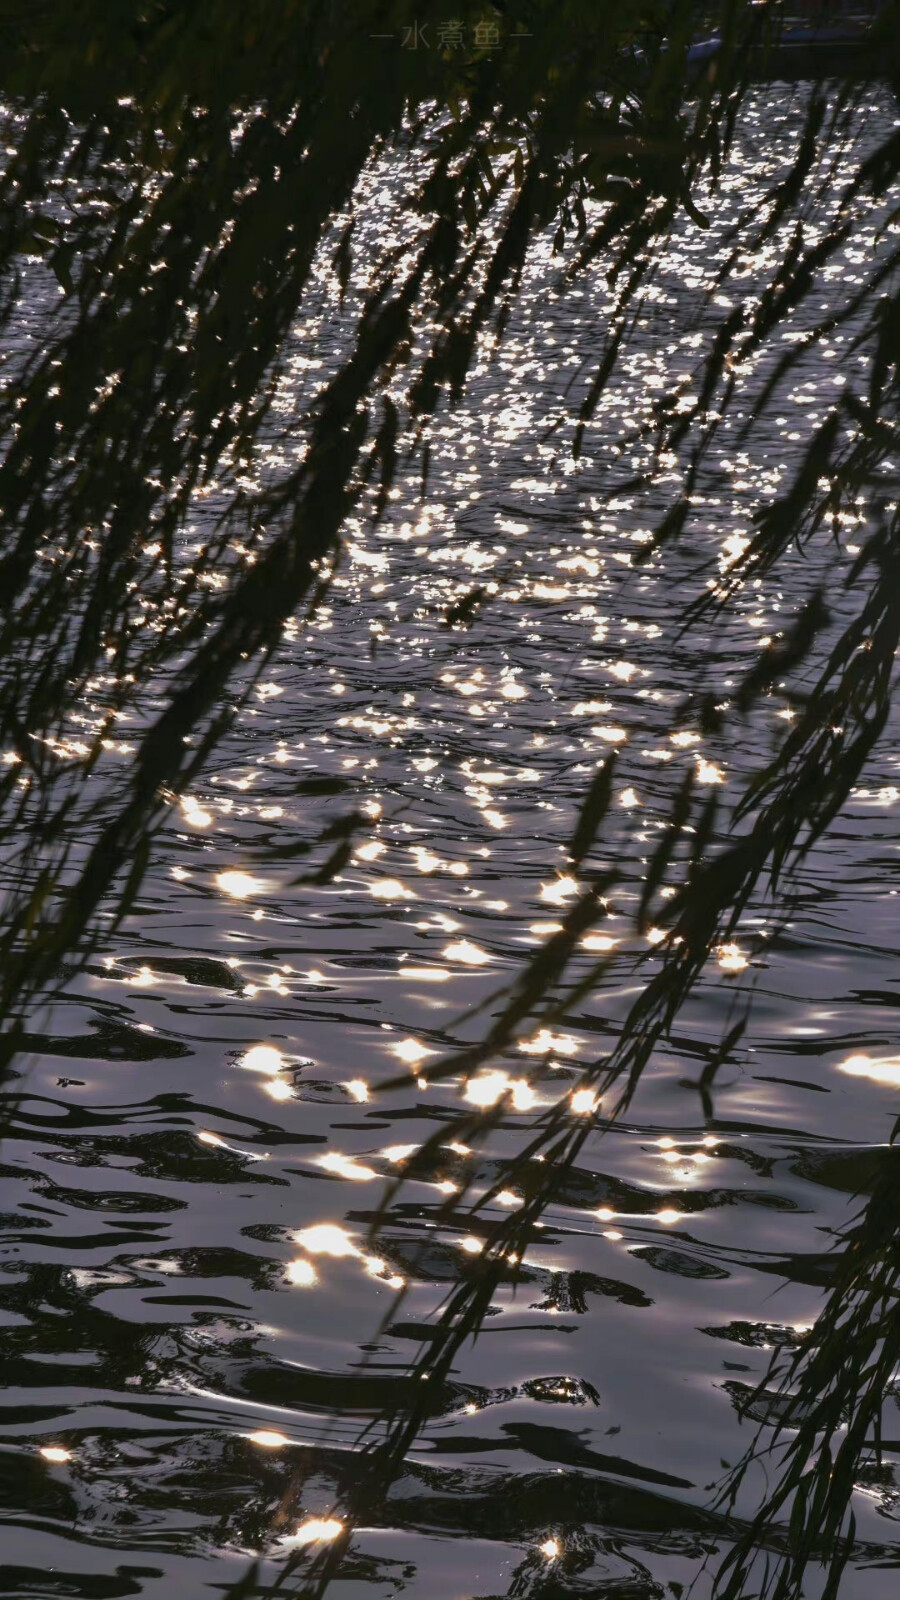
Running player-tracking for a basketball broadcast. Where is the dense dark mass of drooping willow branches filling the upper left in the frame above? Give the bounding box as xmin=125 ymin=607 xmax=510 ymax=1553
xmin=0 ymin=0 xmax=740 ymax=1059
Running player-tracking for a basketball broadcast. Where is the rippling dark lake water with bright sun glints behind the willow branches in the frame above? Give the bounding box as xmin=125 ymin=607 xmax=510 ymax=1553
xmin=0 ymin=88 xmax=900 ymax=1600
